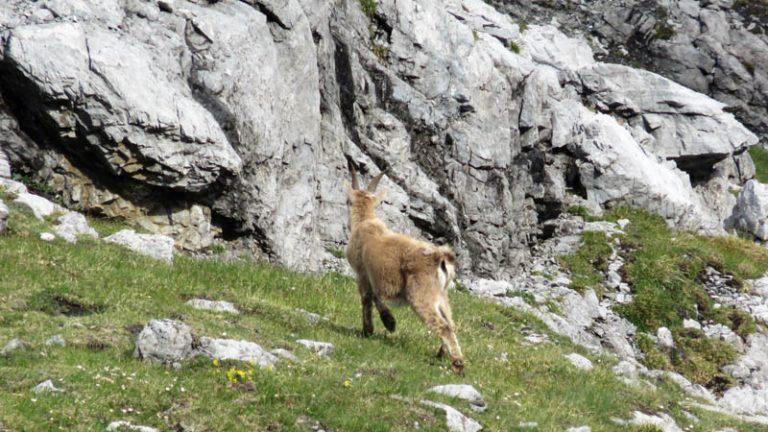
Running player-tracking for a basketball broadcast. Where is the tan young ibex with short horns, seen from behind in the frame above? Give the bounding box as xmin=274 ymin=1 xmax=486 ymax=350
xmin=345 ymin=161 xmax=464 ymax=373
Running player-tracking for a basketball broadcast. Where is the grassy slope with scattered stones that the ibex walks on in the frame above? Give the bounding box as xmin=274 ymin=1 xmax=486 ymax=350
xmin=0 ymin=201 xmax=759 ymax=431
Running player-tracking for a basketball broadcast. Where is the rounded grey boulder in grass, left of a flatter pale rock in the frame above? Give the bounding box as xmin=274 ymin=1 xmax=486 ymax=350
xmin=134 ymin=319 xmax=195 ymax=364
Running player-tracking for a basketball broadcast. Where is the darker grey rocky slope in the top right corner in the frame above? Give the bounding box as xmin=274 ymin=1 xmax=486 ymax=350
xmin=491 ymin=0 xmax=768 ymax=137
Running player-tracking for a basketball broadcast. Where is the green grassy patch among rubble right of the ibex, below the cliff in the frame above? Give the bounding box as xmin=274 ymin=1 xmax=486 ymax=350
xmin=562 ymin=208 xmax=768 ymax=384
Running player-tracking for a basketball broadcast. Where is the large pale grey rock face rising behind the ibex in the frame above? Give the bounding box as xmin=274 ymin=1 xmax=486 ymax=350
xmin=0 ymin=0 xmax=757 ymax=278
